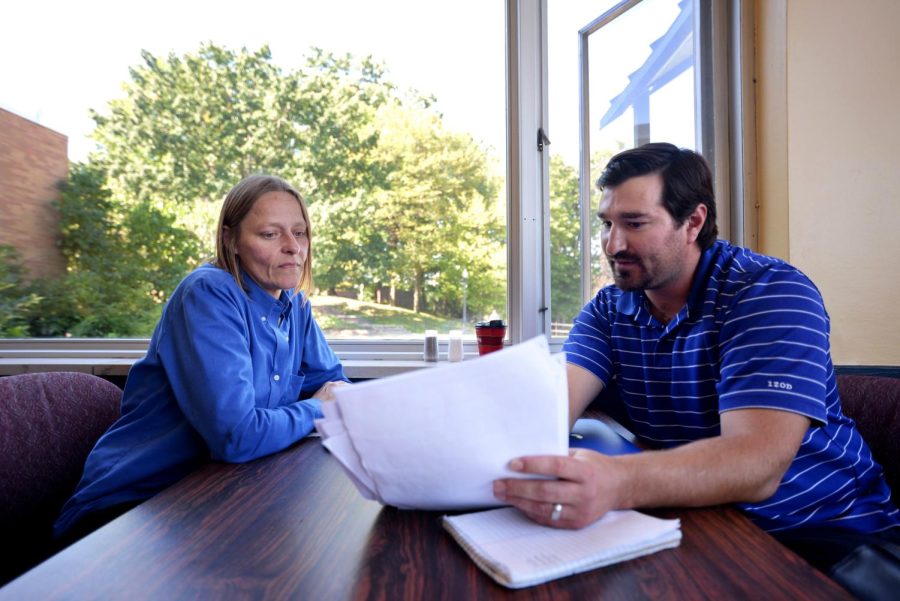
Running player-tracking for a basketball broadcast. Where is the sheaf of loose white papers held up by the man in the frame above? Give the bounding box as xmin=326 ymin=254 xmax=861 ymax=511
xmin=316 ymin=337 xmax=569 ymax=509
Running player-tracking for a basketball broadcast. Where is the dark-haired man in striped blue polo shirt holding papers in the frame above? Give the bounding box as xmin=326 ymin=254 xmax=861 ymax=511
xmin=494 ymin=144 xmax=900 ymax=570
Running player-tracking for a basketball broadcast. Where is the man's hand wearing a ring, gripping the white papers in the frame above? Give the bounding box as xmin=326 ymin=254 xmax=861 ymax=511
xmin=494 ymin=449 xmax=625 ymax=528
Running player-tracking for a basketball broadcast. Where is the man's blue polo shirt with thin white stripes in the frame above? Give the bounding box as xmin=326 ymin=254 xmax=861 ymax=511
xmin=563 ymin=240 xmax=900 ymax=532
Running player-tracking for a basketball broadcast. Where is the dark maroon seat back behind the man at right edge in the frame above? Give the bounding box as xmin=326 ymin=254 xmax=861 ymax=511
xmin=838 ymin=375 xmax=900 ymax=504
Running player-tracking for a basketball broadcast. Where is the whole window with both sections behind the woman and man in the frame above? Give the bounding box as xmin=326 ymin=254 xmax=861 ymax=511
xmin=0 ymin=0 xmax=740 ymax=368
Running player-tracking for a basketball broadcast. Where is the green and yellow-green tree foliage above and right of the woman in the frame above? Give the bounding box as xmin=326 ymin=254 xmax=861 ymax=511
xmin=84 ymin=44 xmax=505 ymax=328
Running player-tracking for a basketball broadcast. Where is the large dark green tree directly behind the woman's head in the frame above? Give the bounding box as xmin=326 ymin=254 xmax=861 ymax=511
xmin=92 ymin=44 xmax=390 ymax=248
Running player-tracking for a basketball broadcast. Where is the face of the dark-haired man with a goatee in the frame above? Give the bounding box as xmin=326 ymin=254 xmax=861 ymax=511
xmin=598 ymin=173 xmax=697 ymax=291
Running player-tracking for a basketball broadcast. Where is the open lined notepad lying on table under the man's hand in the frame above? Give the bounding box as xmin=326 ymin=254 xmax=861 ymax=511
xmin=444 ymin=507 xmax=681 ymax=588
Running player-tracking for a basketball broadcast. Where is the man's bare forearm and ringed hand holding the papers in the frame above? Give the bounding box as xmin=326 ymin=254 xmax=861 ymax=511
xmin=494 ymin=409 xmax=810 ymax=528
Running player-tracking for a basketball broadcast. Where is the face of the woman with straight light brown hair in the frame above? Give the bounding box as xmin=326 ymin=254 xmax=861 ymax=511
xmin=235 ymin=191 xmax=309 ymax=298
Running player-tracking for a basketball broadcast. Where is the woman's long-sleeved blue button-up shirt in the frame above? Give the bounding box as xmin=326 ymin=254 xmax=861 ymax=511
xmin=55 ymin=265 xmax=346 ymax=536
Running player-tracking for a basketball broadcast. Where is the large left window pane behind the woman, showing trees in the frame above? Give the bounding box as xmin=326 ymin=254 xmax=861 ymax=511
xmin=0 ymin=0 xmax=506 ymax=338
